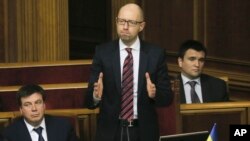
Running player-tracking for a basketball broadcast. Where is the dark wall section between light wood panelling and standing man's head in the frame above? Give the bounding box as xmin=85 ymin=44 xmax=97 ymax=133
xmin=68 ymin=0 xmax=111 ymax=60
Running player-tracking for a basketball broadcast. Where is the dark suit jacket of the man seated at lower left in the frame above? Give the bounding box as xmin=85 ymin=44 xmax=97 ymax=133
xmin=3 ymin=115 xmax=77 ymax=141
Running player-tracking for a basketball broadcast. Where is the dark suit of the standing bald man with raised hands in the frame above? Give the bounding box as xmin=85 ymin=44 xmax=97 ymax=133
xmin=86 ymin=40 xmax=173 ymax=141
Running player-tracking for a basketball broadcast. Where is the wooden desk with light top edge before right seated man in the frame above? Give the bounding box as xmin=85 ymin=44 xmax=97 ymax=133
xmin=180 ymin=101 xmax=250 ymax=141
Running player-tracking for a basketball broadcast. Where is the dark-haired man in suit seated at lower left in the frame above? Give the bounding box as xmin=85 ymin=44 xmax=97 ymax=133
xmin=3 ymin=85 xmax=78 ymax=141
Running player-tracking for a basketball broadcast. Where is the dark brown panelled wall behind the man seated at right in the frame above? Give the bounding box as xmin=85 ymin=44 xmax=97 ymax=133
xmin=143 ymin=0 xmax=250 ymax=76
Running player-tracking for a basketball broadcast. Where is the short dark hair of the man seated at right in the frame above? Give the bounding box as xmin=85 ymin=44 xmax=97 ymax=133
xmin=178 ymin=40 xmax=207 ymax=58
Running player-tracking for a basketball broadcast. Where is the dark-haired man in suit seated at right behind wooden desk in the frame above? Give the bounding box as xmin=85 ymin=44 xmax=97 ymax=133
xmin=178 ymin=40 xmax=229 ymax=104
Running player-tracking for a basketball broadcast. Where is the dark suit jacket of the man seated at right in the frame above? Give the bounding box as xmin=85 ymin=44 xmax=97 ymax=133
xmin=179 ymin=74 xmax=229 ymax=103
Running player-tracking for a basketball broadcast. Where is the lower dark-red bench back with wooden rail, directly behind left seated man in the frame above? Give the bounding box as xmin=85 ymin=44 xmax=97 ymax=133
xmin=0 ymin=83 xmax=87 ymax=112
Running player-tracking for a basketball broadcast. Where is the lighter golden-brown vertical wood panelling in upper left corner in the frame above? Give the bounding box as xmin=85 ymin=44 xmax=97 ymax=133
xmin=0 ymin=0 xmax=69 ymax=62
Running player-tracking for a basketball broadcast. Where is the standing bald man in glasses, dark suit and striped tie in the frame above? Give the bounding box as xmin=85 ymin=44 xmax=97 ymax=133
xmin=86 ymin=4 xmax=173 ymax=141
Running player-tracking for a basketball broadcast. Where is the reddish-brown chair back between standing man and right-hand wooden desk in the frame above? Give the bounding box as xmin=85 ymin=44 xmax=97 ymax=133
xmin=157 ymin=79 xmax=181 ymax=136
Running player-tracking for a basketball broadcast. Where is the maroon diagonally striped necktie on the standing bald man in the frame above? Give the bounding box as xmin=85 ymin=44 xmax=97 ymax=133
xmin=120 ymin=48 xmax=134 ymax=120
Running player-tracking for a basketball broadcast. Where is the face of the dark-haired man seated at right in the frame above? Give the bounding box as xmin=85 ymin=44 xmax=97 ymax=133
xmin=178 ymin=49 xmax=205 ymax=79
